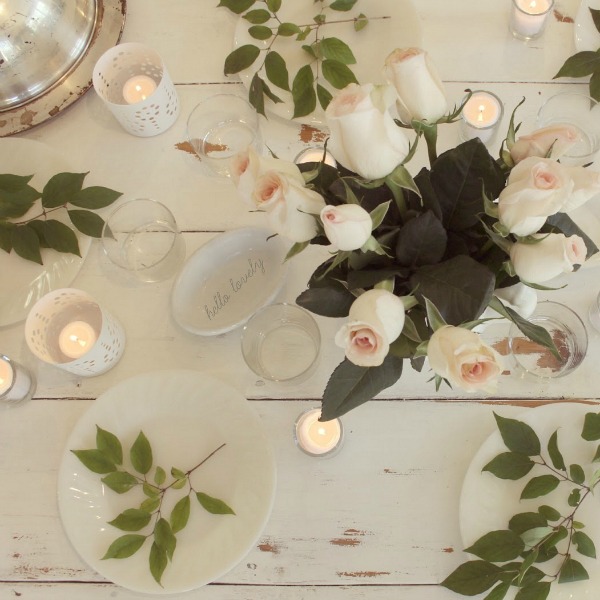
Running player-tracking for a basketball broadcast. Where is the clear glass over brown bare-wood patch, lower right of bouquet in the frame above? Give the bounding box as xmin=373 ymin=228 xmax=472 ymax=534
xmin=508 ymin=301 xmax=588 ymax=378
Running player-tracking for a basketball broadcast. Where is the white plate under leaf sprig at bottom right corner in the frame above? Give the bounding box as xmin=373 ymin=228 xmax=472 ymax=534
xmin=460 ymin=402 xmax=600 ymax=600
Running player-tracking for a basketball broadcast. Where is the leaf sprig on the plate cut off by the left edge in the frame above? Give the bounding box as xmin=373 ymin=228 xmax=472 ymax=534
xmin=0 ymin=173 xmax=121 ymax=265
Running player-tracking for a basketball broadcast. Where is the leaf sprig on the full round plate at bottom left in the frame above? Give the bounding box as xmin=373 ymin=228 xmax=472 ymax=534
xmin=71 ymin=425 xmax=235 ymax=585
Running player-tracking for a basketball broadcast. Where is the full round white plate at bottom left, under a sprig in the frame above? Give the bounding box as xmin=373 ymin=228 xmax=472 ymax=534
xmin=58 ymin=370 xmax=275 ymax=594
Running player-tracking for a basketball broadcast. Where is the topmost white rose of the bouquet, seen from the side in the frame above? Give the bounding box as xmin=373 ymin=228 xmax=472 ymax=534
xmin=384 ymin=48 xmax=448 ymax=123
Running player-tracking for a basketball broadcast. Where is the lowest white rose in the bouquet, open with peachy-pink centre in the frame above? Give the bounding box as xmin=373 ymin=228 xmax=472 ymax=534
xmin=427 ymin=325 xmax=503 ymax=393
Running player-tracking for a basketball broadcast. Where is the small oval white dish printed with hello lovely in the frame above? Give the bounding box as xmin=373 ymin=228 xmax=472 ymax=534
xmin=171 ymin=227 xmax=288 ymax=335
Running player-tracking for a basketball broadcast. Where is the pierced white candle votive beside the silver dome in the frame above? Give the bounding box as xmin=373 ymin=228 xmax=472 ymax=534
xmin=92 ymin=43 xmax=179 ymax=137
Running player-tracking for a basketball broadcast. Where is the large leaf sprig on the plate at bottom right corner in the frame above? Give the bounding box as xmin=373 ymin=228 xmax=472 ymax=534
xmin=442 ymin=413 xmax=600 ymax=600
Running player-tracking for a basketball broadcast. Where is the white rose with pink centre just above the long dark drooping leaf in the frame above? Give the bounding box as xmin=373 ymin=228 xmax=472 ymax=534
xmin=335 ymin=289 xmax=404 ymax=367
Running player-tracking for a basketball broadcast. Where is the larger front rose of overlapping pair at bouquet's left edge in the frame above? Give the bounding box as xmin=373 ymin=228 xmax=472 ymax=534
xmin=264 ymin=171 xmax=325 ymax=242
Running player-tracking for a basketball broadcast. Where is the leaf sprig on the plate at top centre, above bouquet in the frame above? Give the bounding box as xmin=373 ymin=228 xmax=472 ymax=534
xmin=219 ymin=0 xmax=386 ymax=118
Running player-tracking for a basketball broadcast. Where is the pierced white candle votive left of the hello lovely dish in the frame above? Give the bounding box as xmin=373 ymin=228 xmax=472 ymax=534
xmin=25 ymin=288 xmax=125 ymax=377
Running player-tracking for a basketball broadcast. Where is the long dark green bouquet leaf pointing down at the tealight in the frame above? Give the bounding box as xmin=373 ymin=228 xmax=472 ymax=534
xmin=321 ymin=354 xmax=403 ymax=421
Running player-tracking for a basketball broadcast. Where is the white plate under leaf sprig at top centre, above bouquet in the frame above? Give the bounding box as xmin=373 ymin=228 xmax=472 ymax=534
xmin=234 ymin=0 xmax=421 ymax=124
